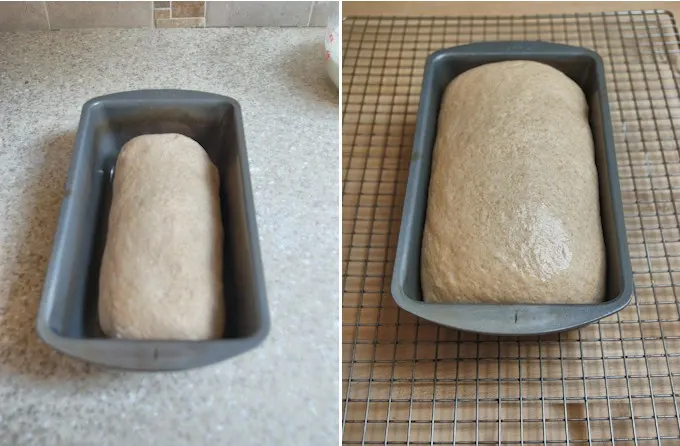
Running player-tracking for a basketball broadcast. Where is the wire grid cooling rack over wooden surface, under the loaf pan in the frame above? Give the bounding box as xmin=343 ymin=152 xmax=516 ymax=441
xmin=342 ymin=11 xmax=680 ymax=445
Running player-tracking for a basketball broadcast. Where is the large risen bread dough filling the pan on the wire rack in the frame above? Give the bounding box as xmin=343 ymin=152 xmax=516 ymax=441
xmin=421 ymin=61 xmax=606 ymax=304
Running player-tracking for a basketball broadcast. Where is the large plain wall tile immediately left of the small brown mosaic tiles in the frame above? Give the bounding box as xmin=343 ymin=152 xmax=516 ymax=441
xmin=47 ymin=1 xmax=153 ymax=29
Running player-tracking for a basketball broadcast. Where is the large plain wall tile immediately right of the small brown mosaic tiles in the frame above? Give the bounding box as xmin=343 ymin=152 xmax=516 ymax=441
xmin=205 ymin=2 xmax=312 ymax=26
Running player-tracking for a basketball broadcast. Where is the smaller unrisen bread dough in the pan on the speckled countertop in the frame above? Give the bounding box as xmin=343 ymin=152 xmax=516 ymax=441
xmin=99 ymin=134 xmax=225 ymax=340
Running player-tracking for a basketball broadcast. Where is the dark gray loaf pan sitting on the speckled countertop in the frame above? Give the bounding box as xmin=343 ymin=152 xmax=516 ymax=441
xmin=37 ymin=90 xmax=269 ymax=371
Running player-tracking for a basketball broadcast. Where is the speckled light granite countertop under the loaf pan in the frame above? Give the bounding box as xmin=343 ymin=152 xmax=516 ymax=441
xmin=0 ymin=29 xmax=339 ymax=446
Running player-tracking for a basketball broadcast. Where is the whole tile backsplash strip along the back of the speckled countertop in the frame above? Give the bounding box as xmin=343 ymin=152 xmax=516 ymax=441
xmin=0 ymin=1 xmax=338 ymax=31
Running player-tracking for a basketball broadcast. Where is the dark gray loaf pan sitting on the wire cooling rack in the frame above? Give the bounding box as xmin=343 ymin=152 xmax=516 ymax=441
xmin=392 ymin=42 xmax=633 ymax=336
